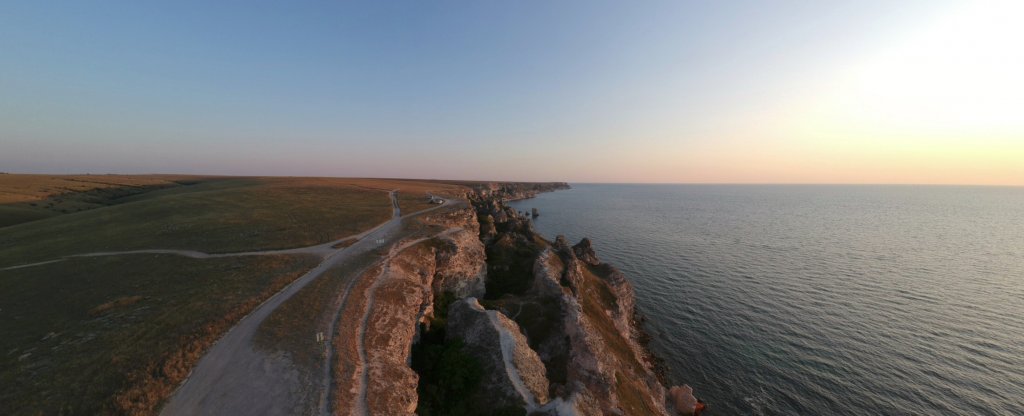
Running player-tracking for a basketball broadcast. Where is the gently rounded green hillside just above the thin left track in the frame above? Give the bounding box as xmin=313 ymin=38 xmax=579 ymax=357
xmin=0 ymin=178 xmax=391 ymax=267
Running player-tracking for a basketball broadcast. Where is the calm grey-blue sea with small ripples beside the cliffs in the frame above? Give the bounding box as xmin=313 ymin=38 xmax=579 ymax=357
xmin=513 ymin=184 xmax=1024 ymax=415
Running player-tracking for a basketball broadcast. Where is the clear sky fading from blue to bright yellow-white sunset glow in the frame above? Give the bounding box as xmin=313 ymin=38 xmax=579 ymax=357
xmin=0 ymin=0 xmax=1024 ymax=185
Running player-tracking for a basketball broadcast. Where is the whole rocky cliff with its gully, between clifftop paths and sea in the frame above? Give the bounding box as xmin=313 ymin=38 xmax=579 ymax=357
xmin=354 ymin=184 xmax=692 ymax=416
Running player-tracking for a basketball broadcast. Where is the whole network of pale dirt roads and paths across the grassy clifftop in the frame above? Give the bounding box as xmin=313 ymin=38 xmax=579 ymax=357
xmin=0 ymin=190 xmax=462 ymax=416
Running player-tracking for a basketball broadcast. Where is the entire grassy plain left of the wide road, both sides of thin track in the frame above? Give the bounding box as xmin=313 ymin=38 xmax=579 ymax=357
xmin=0 ymin=174 xmax=471 ymax=415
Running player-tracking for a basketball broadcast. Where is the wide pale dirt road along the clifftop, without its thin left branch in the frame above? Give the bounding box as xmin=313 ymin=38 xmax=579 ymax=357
xmin=161 ymin=192 xmax=450 ymax=416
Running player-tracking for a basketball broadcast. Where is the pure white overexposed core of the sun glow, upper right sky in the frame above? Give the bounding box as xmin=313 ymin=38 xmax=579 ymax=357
xmin=802 ymin=1 xmax=1024 ymax=139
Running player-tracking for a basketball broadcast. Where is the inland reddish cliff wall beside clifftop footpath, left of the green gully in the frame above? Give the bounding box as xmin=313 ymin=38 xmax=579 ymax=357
xmin=344 ymin=202 xmax=486 ymax=415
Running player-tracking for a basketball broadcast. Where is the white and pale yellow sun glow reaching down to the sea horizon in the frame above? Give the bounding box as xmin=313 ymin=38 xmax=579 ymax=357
xmin=753 ymin=2 xmax=1024 ymax=184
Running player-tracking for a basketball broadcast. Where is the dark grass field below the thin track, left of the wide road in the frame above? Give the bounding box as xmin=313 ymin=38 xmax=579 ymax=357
xmin=0 ymin=254 xmax=318 ymax=415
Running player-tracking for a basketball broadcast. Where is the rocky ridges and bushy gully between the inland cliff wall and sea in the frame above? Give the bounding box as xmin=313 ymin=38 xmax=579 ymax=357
xmin=403 ymin=183 xmax=692 ymax=416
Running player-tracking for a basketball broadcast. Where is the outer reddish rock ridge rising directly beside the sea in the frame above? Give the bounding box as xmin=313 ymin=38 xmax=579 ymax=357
xmin=449 ymin=189 xmax=687 ymax=415
